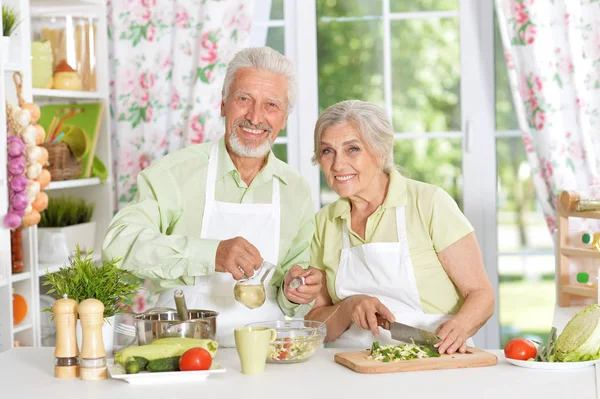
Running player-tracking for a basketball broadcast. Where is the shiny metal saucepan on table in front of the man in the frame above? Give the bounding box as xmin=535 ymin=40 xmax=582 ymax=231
xmin=133 ymin=309 xmax=219 ymax=345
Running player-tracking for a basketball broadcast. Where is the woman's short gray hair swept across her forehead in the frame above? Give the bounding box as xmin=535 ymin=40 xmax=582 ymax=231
xmin=312 ymin=100 xmax=395 ymax=174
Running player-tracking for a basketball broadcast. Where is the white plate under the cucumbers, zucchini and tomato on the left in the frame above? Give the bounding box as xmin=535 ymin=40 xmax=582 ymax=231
xmin=107 ymin=359 xmax=226 ymax=385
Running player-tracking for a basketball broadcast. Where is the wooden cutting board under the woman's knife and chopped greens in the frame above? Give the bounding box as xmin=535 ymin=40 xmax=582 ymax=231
xmin=334 ymin=347 xmax=498 ymax=374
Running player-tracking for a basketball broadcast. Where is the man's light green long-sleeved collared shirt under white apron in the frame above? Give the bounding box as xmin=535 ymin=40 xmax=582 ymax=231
xmin=102 ymin=138 xmax=315 ymax=317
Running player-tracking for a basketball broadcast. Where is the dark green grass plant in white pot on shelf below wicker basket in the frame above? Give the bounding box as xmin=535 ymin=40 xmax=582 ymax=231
xmin=38 ymin=197 xmax=96 ymax=263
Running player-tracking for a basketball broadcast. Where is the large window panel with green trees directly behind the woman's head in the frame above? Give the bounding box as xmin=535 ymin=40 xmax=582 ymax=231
xmin=317 ymin=0 xmax=462 ymax=209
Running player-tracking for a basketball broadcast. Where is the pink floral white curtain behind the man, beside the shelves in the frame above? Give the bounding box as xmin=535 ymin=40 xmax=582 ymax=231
xmin=108 ymin=0 xmax=254 ymax=312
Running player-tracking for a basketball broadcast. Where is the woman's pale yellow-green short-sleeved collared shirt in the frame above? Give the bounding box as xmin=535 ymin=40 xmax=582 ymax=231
xmin=310 ymin=170 xmax=473 ymax=314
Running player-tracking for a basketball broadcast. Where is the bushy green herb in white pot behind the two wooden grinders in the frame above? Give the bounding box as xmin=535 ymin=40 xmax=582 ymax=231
xmin=42 ymin=247 xmax=140 ymax=354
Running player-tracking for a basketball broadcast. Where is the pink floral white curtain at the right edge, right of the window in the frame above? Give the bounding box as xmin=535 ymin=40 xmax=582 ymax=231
xmin=496 ymin=0 xmax=600 ymax=236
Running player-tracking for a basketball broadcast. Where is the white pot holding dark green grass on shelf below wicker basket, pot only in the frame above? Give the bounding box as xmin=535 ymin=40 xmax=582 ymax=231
xmin=38 ymin=222 xmax=96 ymax=263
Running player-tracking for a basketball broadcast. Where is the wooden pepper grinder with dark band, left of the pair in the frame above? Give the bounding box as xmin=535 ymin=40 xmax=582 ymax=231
xmin=52 ymin=295 xmax=79 ymax=378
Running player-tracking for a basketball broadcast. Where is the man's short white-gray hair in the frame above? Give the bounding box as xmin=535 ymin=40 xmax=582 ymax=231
xmin=221 ymin=47 xmax=296 ymax=113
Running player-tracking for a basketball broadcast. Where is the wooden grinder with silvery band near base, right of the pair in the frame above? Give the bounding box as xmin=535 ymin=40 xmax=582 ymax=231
xmin=79 ymin=298 xmax=107 ymax=381
